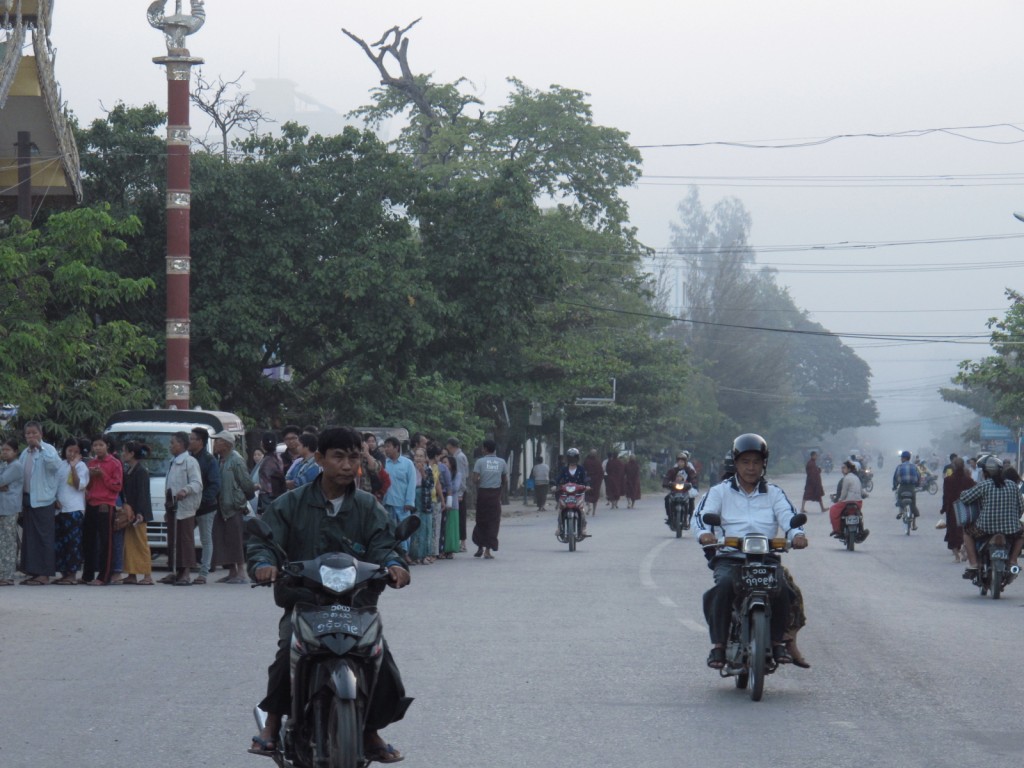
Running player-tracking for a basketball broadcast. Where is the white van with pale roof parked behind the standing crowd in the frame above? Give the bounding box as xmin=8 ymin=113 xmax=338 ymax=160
xmin=104 ymin=409 xmax=246 ymax=554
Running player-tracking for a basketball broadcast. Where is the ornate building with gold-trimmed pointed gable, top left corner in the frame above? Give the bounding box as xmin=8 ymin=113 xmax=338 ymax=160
xmin=0 ymin=0 xmax=82 ymax=219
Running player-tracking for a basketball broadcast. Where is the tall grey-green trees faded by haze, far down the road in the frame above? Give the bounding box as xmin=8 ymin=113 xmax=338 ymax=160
xmin=672 ymin=188 xmax=878 ymax=446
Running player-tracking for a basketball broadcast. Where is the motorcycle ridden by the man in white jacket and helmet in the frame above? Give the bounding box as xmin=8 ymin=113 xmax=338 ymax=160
xmin=703 ymin=512 xmax=807 ymax=701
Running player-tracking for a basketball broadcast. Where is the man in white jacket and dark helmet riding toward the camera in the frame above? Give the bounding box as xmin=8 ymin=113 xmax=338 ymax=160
xmin=696 ymin=433 xmax=807 ymax=670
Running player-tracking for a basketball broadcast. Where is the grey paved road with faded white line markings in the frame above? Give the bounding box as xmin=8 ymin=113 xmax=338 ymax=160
xmin=0 ymin=474 xmax=1024 ymax=768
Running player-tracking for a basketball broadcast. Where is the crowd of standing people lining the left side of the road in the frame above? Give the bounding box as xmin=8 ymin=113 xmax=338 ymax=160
xmin=0 ymin=421 xmax=540 ymax=587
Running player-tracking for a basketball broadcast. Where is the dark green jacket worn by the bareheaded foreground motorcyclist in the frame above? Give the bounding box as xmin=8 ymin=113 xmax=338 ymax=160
xmin=246 ymin=477 xmax=406 ymax=607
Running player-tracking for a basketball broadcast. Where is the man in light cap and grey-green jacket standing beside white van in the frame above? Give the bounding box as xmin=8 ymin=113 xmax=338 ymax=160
xmin=213 ymin=429 xmax=253 ymax=584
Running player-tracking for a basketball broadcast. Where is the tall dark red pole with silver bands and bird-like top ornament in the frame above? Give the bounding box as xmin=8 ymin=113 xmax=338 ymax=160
xmin=147 ymin=0 xmax=206 ymax=409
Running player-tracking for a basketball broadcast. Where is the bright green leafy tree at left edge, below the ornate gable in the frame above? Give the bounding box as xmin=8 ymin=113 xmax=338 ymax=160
xmin=0 ymin=207 xmax=157 ymax=437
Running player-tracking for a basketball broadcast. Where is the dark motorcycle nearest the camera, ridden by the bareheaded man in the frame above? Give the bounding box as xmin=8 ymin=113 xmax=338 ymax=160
xmin=246 ymin=515 xmax=420 ymax=768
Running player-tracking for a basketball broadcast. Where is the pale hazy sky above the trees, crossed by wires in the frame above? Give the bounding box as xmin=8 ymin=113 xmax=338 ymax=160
xmin=52 ymin=0 xmax=1024 ymax=451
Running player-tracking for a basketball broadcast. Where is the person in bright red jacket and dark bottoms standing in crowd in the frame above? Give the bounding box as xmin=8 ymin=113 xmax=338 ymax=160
xmin=82 ymin=435 xmax=124 ymax=587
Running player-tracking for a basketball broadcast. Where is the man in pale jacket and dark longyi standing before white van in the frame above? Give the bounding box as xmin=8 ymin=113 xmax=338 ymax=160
xmin=160 ymin=432 xmax=203 ymax=587
